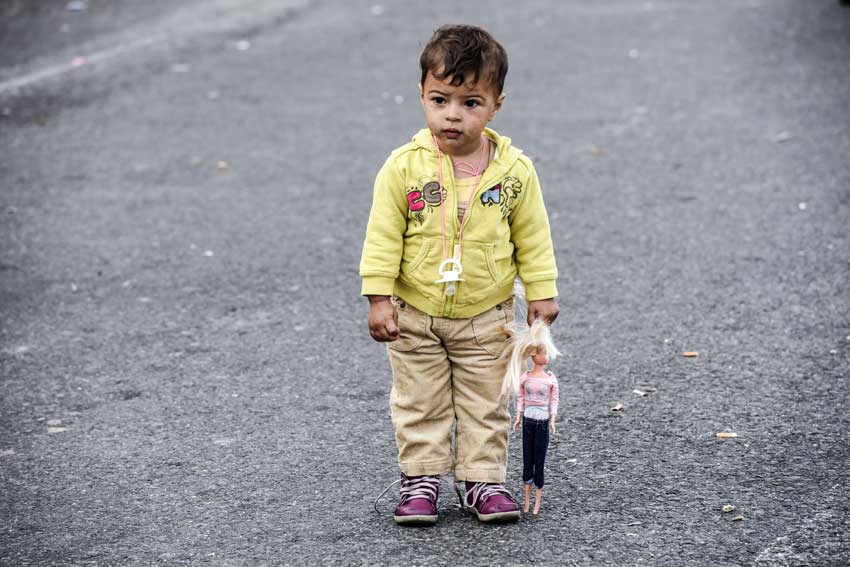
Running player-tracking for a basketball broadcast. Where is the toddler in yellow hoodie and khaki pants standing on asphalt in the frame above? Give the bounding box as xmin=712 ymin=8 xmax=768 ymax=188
xmin=360 ymin=26 xmax=558 ymax=524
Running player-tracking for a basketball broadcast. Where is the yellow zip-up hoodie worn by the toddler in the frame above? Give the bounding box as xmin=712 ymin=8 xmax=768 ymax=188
xmin=360 ymin=129 xmax=558 ymax=318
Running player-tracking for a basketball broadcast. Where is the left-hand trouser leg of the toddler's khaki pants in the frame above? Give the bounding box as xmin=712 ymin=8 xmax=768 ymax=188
xmin=388 ymin=303 xmax=454 ymax=476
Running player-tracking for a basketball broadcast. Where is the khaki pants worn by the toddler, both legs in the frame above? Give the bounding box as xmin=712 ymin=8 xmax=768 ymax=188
xmin=388 ymin=299 xmax=514 ymax=482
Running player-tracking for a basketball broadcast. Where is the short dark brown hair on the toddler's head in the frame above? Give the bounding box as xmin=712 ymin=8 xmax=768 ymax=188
xmin=419 ymin=25 xmax=508 ymax=96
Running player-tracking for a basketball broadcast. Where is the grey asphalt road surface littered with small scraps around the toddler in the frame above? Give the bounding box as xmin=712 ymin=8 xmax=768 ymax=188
xmin=0 ymin=0 xmax=850 ymax=566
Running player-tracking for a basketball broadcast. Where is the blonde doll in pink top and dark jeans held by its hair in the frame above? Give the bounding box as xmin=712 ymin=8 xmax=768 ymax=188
xmin=502 ymin=319 xmax=560 ymax=516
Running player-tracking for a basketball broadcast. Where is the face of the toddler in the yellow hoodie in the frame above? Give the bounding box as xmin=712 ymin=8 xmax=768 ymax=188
xmin=419 ymin=73 xmax=505 ymax=160
